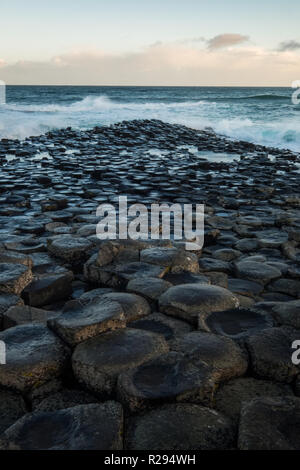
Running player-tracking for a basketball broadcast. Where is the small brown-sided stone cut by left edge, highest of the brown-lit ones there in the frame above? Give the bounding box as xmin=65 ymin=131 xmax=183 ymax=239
xmin=0 ymin=263 xmax=32 ymax=295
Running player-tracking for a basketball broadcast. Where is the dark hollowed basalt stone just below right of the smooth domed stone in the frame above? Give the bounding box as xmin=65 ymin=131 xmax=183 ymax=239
xmin=198 ymin=308 xmax=274 ymax=340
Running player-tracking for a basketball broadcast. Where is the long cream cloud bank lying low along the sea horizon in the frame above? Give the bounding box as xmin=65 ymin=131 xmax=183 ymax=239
xmin=0 ymin=42 xmax=300 ymax=86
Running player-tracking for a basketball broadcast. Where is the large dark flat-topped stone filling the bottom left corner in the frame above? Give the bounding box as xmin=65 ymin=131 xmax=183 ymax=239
xmin=0 ymin=402 xmax=123 ymax=450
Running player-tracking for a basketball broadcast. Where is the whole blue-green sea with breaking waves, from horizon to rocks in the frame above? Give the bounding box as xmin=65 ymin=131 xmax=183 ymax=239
xmin=0 ymin=86 xmax=300 ymax=151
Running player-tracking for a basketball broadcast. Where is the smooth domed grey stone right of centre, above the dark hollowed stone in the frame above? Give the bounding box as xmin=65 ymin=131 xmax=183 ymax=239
xmin=159 ymin=284 xmax=239 ymax=324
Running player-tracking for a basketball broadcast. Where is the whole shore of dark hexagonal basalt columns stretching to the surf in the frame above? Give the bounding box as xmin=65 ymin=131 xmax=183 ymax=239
xmin=0 ymin=120 xmax=300 ymax=450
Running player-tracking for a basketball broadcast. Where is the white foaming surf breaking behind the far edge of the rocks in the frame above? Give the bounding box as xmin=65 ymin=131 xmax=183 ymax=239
xmin=0 ymin=95 xmax=300 ymax=151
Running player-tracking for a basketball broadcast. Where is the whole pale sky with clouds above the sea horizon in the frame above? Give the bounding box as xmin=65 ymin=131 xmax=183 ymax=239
xmin=0 ymin=0 xmax=300 ymax=86
